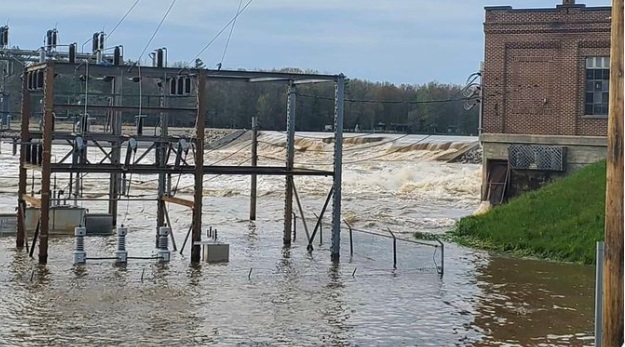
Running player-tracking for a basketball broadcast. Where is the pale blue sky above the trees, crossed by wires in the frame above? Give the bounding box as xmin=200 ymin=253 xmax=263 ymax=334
xmin=0 ymin=0 xmax=611 ymax=84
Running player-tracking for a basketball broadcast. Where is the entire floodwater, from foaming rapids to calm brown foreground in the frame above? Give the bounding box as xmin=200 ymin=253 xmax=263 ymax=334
xmin=0 ymin=133 xmax=594 ymax=346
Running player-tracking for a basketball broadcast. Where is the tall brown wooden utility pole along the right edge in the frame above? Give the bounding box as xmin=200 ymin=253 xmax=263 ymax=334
xmin=602 ymin=0 xmax=624 ymax=347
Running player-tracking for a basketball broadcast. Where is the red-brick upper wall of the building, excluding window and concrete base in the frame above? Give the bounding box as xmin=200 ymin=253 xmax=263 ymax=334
xmin=483 ymin=1 xmax=611 ymax=136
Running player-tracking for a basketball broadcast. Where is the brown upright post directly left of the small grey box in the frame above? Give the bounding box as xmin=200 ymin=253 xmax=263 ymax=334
xmin=191 ymin=70 xmax=207 ymax=263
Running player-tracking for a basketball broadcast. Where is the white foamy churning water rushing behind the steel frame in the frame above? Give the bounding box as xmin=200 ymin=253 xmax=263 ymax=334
xmin=0 ymin=132 xmax=481 ymax=232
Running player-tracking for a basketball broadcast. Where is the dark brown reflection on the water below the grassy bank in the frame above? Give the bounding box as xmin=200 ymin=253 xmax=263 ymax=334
xmin=475 ymin=258 xmax=595 ymax=346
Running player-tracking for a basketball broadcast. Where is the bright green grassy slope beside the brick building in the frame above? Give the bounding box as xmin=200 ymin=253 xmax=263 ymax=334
xmin=450 ymin=161 xmax=606 ymax=264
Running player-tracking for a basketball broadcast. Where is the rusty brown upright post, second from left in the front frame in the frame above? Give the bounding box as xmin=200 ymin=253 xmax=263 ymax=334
xmin=39 ymin=62 xmax=54 ymax=264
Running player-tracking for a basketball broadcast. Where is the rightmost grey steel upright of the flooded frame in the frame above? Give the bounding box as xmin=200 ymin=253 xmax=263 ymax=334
xmin=330 ymin=75 xmax=345 ymax=262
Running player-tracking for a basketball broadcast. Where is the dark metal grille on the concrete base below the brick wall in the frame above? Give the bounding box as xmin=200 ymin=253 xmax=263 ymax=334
xmin=508 ymin=145 xmax=566 ymax=171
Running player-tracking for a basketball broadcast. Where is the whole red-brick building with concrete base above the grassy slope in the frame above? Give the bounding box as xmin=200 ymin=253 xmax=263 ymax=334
xmin=480 ymin=0 xmax=611 ymax=204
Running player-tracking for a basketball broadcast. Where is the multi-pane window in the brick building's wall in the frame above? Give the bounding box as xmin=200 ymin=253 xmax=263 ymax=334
xmin=584 ymin=57 xmax=610 ymax=116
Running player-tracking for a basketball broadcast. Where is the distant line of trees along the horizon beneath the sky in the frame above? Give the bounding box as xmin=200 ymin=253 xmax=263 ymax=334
xmin=0 ymin=64 xmax=478 ymax=135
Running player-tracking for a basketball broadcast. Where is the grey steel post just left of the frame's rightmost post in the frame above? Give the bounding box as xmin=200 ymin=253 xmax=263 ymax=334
xmin=282 ymin=84 xmax=297 ymax=245
